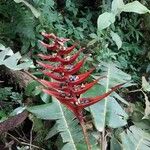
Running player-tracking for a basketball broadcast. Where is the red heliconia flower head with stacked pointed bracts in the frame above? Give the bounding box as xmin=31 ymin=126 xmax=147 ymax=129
xmin=38 ymin=33 xmax=122 ymax=122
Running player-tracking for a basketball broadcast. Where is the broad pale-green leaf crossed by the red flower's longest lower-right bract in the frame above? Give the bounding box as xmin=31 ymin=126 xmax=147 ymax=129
xmin=83 ymin=63 xmax=131 ymax=132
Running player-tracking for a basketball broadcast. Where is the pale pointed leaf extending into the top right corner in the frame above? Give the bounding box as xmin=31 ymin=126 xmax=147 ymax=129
xmin=122 ymin=1 xmax=150 ymax=14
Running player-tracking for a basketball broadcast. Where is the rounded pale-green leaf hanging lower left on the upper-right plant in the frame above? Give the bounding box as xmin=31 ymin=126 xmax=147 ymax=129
xmin=97 ymin=12 xmax=115 ymax=31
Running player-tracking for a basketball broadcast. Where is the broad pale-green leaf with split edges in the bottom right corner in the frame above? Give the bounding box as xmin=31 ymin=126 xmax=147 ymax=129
xmin=120 ymin=126 xmax=150 ymax=150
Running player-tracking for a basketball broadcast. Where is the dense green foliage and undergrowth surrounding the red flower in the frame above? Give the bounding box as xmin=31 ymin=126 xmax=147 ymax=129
xmin=0 ymin=0 xmax=150 ymax=150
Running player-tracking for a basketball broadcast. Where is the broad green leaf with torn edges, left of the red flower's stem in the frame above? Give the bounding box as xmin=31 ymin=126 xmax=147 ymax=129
xmin=27 ymin=98 xmax=95 ymax=150
